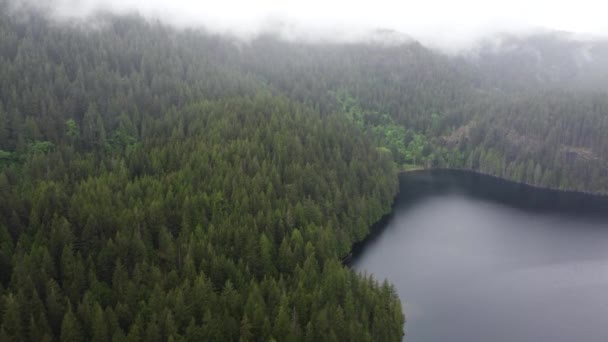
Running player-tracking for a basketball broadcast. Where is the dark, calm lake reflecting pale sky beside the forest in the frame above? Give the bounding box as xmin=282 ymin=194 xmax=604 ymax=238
xmin=351 ymin=170 xmax=608 ymax=342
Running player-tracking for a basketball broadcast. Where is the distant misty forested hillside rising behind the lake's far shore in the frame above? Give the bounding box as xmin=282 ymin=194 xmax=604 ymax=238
xmin=234 ymin=34 xmax=608 ymax=193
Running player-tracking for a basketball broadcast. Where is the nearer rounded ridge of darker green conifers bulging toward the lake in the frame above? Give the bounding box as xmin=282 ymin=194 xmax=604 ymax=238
xmin=0 ymin=73 xmax=403 ymax=341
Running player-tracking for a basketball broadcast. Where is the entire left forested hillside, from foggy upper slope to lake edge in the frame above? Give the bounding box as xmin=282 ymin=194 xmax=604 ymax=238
xmin=0 ymin=6 xmax=404 ymax=341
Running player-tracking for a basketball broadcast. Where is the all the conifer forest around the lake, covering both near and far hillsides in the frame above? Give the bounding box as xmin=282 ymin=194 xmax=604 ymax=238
xmin=0 ymin=1 xmax=608 ymax=341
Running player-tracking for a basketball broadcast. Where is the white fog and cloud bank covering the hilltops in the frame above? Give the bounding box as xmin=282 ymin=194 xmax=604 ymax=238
xmin=11 ymin=0 xmax=608 ymax=50
